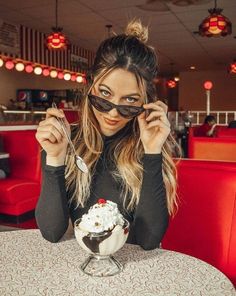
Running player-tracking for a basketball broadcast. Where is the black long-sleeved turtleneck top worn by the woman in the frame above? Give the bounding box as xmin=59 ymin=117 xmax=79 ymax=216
xmin=35 ymin=130 xmax=169 ymax=250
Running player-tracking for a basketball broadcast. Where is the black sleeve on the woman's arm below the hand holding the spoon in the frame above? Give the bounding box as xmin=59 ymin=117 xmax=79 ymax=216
xmin=35 ymin=151 xmax=69 ymax=242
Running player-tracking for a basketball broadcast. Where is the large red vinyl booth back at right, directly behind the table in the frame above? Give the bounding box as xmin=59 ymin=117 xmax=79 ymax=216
xmin=162 ymin=160 xmax=236 ymax=285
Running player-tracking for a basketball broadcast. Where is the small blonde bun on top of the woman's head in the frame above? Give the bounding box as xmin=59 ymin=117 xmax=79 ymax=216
xmin=125 ymin=19 xmax=148 ymax=43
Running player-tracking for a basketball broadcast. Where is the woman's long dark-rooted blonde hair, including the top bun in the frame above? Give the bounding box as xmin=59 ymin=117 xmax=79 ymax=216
xmin=66 ymin=20 xmax=177 ymax=214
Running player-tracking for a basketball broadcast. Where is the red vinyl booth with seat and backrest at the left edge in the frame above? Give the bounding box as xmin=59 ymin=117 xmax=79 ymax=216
xmin=0 ymin=130 xmax=41 ymax=221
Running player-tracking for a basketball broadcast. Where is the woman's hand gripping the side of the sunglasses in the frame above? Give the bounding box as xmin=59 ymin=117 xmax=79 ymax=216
xmin=138 ymin=101 xmax=170 ymax=154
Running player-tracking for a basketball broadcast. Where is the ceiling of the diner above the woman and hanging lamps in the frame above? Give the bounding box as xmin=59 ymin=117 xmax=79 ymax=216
xmin=0 ymin=0 xmax=236 ymax=73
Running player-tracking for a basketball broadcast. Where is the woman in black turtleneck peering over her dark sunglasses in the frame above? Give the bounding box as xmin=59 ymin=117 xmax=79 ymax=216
xmin=36 ymin=21 xmax=176 ymax=249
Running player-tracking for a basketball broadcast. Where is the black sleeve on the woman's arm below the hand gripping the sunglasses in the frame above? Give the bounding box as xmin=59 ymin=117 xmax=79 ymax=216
xmin=133 ymin=154 xmax=169 ymax=250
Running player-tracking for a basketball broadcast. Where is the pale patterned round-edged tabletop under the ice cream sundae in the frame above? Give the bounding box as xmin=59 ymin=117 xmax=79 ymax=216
xmin=0 ymin=230 xmax=236 ymax=296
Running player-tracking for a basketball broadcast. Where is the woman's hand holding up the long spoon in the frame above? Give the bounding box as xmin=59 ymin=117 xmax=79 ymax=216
xmin=36 ymin=108 xmax=70 ymax=166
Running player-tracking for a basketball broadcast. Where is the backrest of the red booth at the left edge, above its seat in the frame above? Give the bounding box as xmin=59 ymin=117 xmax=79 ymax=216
xmin=0 ymin=130 xmax=41 ymax=181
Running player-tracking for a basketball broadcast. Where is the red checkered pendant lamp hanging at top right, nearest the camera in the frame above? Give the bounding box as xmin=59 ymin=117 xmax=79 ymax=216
xmin=199 ymin=0 xmax=232 ymax=37
